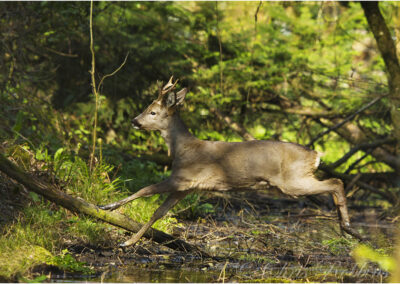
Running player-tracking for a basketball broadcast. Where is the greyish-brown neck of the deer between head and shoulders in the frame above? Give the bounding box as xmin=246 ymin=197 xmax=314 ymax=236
xmin=161 ymin=113 xmax=197 ymax=159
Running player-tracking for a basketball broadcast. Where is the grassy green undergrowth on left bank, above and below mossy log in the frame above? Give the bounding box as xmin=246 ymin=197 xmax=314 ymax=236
xmin=0 ymin=105 xmax=191 ymax=282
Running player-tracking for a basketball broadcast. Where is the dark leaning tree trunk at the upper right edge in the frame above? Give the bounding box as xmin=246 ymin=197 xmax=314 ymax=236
xmin=360 ymin=1 xmax=400 ymax=173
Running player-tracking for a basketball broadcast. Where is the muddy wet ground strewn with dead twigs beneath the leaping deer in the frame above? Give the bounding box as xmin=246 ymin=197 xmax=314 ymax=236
xmin=52 ymin=192 xmax=396 ymax=282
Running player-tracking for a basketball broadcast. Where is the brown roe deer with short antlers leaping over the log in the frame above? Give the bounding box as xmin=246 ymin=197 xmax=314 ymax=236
xmin=100 ymin=77 xmax=350 ymax=246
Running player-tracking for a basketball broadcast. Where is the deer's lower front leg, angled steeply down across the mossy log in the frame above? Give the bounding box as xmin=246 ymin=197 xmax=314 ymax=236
xmin=120 ymin=190 xmax=191 ymax=247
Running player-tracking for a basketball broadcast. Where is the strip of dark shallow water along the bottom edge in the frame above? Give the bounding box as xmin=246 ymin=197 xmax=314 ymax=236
xmin=51 ymin=261 xmax=389 ymax=283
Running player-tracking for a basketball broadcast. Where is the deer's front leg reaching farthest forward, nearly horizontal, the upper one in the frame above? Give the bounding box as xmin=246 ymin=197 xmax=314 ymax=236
xmin=98 ymin=179 xmax=175 ymax=210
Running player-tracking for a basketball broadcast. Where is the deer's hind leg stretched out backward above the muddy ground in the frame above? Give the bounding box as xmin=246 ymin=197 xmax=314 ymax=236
xmin=284 ymin=176 xmax=350 ymax=227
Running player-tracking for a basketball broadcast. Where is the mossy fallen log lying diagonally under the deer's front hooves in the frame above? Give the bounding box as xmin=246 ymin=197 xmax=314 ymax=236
xmin=0 ymin=154 xmax=208 ymax=257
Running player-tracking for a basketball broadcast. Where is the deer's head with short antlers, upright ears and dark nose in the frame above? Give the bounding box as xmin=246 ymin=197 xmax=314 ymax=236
xmin=132 ymin=76 xmax=187 ymax=131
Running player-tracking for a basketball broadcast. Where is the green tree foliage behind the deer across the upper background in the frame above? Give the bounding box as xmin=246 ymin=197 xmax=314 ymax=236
xmin=2 ymin=2 xmax=393 ymax=178
